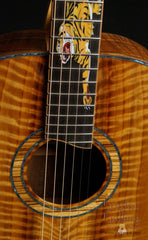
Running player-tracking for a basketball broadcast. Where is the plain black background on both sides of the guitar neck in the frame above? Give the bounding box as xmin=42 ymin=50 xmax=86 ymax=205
xmin=0 ymin=0 xmax=148 ymax=48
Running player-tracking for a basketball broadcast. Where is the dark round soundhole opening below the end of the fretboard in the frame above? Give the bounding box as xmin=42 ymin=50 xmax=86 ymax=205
xmin=27 ymin=141 xmax=106 ymax=204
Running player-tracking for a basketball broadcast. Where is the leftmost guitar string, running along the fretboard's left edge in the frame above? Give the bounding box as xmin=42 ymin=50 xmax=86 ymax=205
xmin=41 ymin=0 xmax=56 ymax=240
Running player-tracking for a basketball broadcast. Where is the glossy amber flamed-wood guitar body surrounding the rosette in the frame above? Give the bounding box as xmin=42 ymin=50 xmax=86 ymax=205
xmin=0 ymin=31 xmax=148 ymax=240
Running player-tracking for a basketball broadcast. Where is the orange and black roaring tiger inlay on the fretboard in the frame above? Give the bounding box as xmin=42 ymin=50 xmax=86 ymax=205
xmin=56 ymin=1 xmax=101 ymax=105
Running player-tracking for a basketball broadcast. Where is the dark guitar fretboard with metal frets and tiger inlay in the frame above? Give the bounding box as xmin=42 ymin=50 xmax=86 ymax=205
xmin=46 ymin=0 xmax=102 ymax=148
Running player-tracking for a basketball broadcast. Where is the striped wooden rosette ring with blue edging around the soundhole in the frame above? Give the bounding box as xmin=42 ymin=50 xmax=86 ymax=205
xmin=10 ymin=129 xmax=122 ymax=218
